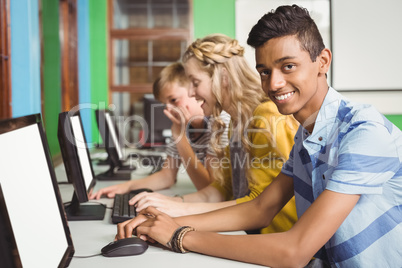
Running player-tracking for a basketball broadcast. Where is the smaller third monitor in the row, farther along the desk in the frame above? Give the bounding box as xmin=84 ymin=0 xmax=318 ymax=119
xmin=95 ymin=109 xmax=136 ymax=180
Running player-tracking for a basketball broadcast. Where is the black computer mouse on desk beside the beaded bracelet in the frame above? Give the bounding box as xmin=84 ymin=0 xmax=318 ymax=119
xmin=101 ymin=237 xmax=148 ymax=257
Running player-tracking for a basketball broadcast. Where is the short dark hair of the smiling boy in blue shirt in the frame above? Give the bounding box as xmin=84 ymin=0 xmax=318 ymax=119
xmin=247 ymin=5 xmax=325 ymax=62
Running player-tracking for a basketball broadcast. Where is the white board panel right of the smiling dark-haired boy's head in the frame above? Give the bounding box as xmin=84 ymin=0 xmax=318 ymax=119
xmin=332 ymin=0 xmax=402 ymax=90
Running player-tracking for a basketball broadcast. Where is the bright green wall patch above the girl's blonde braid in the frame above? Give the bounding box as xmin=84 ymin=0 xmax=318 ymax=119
xmin=193 ymin=0 xmax=236 ymax=38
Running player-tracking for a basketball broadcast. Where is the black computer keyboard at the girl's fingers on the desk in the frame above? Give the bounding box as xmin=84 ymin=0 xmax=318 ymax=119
xmin=112 ymin=188 xmax=152 ymax=223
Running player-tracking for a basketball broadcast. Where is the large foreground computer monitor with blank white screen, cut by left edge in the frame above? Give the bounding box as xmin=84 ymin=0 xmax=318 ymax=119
xmin=0 ymin=114 xmax=74 ymax=267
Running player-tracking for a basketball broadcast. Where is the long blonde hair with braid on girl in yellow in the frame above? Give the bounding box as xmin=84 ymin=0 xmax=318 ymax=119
xmin=183 ymin=34 xmax=268 ymax=183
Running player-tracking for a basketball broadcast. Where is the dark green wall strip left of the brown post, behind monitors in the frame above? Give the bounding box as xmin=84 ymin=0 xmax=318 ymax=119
xmin=42 ymin=0 xmax=61 ymax=155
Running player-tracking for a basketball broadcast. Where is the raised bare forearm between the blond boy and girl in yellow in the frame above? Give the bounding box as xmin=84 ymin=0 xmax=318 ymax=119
xmin=176 ymin=137 xmax=212 ymax=190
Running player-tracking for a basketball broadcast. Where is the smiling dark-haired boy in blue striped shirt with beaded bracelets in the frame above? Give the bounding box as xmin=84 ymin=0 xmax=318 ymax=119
xmin=116 ymin=5 xmax=402 ymax=268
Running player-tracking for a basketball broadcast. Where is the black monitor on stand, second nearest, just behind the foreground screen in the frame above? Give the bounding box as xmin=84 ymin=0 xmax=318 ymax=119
xmin=57 ymin=112 xmax=105 ymax=221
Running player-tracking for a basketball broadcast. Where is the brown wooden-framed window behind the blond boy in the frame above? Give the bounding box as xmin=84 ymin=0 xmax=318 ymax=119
xmin=108 ymin=0 xmax=192 ymax=141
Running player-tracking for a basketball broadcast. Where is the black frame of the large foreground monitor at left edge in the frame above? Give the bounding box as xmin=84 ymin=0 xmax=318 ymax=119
xmin=0 ymin=114 xmax=74 ymax=267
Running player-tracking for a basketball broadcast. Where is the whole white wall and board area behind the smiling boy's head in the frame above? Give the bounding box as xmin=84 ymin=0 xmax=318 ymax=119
xmin=236 ymin=0 xmax=402 ymax=114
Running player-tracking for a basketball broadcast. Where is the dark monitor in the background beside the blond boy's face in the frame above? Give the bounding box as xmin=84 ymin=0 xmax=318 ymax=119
xmin=141 ymin=95 xmax=172 ymax=148
